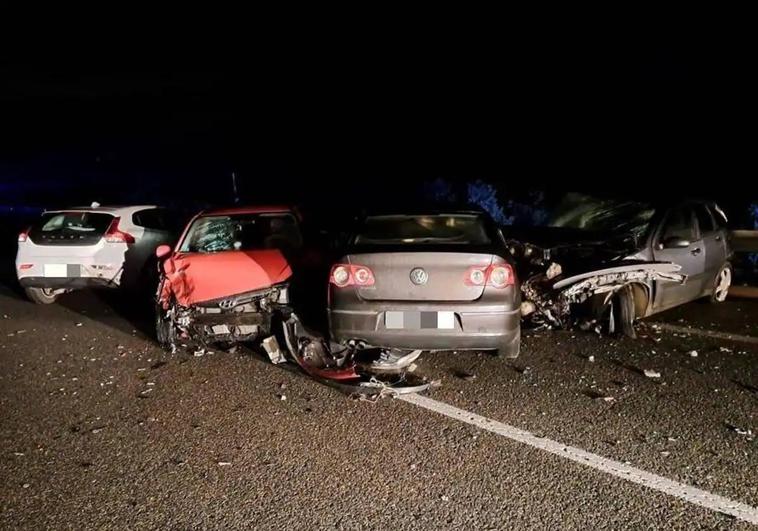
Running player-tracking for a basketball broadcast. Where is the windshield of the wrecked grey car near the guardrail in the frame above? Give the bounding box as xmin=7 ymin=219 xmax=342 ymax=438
xmin=548 ymin=193 xmax=655 ymax=234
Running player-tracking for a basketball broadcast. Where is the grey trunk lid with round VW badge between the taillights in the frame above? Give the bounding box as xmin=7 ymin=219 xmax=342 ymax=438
xmin=347 ymin=252 xmax=493 ymax=301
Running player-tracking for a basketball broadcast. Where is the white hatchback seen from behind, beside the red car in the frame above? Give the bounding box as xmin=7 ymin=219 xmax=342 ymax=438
xmin=16 ymin=203 xmax=176 ymax=304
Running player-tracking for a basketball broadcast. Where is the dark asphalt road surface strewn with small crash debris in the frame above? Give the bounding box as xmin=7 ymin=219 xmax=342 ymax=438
xmin=0 ymin=280 xmax=758 ymax=529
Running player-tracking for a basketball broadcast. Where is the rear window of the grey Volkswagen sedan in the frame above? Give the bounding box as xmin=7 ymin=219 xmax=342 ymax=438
xmin=353 ymin=214 xmax=490 ymax=245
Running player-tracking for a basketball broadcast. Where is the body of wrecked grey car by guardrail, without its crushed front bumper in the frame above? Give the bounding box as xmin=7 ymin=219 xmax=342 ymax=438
xmin=536 ymin=198 xmax=732 ymax=317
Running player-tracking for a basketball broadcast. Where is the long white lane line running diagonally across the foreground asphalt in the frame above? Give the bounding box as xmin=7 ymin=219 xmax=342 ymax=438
xmin=397 ymin=394 xmax=758 ymax=524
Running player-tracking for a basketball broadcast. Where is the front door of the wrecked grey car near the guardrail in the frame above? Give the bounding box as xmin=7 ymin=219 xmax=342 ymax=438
xmin=653 ymin=205 xmax=705 ymax=311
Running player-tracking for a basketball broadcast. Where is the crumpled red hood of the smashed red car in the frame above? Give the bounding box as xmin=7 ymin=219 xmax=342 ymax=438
xmin=161 ymin=249 xmax=292 ymax=306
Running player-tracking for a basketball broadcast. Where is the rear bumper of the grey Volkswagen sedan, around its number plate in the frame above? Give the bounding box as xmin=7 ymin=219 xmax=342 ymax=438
xmin=329 ymin=303 xmax=521 ymax=350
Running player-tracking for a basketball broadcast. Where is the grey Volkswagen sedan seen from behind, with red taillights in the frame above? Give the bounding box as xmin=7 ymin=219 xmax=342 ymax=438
xmin=328 ymin=211 xmax=521 ymax=358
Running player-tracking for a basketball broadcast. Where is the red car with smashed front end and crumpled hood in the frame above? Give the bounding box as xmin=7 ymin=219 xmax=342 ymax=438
xmin=156 ymin=206 xmax=303 ymax=349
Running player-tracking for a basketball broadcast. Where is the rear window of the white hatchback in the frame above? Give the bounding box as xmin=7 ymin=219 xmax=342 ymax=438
xmin=29 ymin=212 xmax=113 ymax=244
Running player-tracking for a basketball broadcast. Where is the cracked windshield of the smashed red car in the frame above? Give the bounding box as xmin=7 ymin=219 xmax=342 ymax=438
xmin=179 ymin=214 xmax=302 ymax=253
